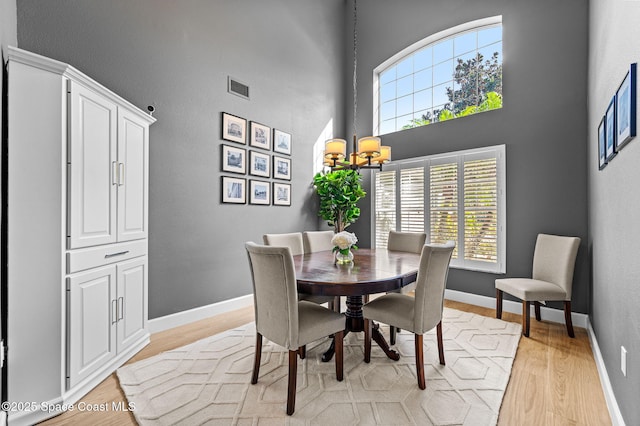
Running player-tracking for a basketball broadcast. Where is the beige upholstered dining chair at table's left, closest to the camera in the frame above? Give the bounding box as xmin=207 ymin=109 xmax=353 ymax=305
xmin=245 ymin=242 xmax=345 ymax=415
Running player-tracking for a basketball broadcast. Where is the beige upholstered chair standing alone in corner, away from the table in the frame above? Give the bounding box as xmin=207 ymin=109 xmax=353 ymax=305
xmin=496 ymin=234 xmax=580 ymax=337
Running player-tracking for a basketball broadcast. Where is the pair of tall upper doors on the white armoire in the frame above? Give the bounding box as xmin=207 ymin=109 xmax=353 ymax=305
xmin=68 ymin=81 xmax=149 ymax=249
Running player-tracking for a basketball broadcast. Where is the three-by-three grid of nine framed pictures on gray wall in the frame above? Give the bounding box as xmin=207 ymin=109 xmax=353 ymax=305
xmin=220 ymin=112 xmax=292 ymax=206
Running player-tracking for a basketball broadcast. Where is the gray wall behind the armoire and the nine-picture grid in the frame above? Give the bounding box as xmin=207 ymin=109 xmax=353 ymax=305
xmin=18 ymin=0 xmax=344 ymax=318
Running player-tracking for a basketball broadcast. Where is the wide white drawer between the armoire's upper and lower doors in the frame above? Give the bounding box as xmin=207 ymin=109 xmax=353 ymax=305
xmin=67 ymin=239 xmax=147 ymax=274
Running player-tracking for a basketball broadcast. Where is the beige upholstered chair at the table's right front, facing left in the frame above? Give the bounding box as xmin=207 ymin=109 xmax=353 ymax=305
xmin=362 ymin=242 xmax=455 ymax=389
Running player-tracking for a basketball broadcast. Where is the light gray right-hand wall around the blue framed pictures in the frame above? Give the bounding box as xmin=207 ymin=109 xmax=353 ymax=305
xmin=587 ymin=0 xmax=640 ymax=425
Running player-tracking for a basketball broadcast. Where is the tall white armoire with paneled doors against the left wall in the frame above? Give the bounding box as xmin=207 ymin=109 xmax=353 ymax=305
xmin=7 ymin=48 xmax=155 ymax=424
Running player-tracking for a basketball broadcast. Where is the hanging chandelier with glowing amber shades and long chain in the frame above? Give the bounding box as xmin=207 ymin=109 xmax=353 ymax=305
xmin=324 ymin=0 xmax=391 ymax=170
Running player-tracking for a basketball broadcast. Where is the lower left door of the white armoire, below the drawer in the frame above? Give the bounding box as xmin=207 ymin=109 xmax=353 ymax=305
xmin=67 ymin=265 xmax=117 ymax=387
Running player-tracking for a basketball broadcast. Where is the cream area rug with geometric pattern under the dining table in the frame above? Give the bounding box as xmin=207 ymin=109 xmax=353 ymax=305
xmin=117 ymin=308 xmax=521 ymax=425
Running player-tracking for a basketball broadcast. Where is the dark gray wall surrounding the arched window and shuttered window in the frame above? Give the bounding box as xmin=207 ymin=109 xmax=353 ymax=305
xmin=347 ymin=0 xmax=589 ymax=312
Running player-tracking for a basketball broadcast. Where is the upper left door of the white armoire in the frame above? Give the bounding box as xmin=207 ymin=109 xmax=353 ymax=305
xmin=68 ymin=81 xmax=118 ymax=248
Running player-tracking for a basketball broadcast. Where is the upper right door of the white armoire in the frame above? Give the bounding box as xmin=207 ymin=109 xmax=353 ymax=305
xmin=118 ymin=108 xmax=149 ymax=241
